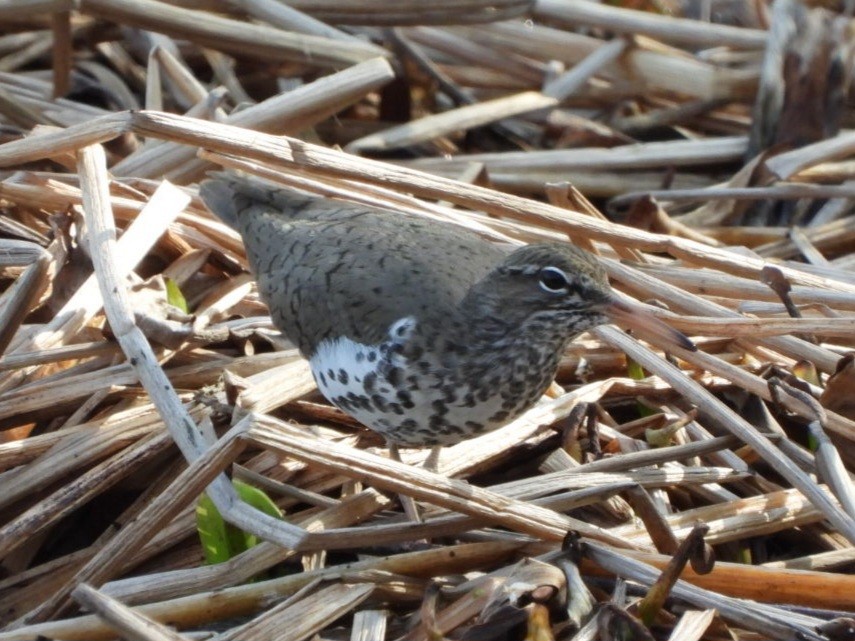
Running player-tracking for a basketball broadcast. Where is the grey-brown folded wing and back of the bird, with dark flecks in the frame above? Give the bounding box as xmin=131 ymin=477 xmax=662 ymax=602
xmin=201 ymin=179 xmax=505 ymax=356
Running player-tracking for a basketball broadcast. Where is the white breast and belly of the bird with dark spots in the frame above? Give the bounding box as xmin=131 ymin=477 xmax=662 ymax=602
xmin=310 ymin=319 xmax=557 ymax=447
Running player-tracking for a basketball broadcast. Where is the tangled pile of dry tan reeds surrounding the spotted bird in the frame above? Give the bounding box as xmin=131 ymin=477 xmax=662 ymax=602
xmin=0 ymin=0 xmax=855 ymax=641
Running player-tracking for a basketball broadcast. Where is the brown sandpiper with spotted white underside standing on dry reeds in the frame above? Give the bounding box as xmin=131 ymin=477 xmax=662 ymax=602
xmin=199 ymin=172 xmax=694 ymax=453
